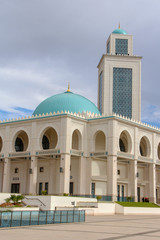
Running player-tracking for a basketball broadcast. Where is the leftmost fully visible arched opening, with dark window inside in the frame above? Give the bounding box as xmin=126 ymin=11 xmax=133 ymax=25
xmin=15 ymin=131 xmax=28 ymax=152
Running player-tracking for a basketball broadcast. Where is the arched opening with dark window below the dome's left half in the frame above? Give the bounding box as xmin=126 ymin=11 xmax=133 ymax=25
xmin=42 ymin=127 xmax=58 ymax=150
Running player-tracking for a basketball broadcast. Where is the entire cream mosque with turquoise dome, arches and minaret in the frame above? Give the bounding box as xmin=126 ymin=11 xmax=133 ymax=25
xmin=0 ymin=27 xmax=160 ymax=203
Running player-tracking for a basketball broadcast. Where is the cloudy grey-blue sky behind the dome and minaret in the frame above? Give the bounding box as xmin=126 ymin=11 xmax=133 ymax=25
xmin=0 ymin=0 xmax=160 ymax=127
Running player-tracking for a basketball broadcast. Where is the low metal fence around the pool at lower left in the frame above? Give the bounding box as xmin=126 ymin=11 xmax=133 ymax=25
xmin=0 ymin=210 xmax=85 ymax=228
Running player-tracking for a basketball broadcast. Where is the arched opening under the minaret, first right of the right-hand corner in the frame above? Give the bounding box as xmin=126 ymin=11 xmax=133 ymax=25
xmin=119 ymin=131 xmax=131 ymax=152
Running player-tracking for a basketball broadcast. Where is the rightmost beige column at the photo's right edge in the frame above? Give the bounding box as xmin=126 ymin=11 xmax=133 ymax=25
xmin=149 ymin=163 xmax=156 ymax=203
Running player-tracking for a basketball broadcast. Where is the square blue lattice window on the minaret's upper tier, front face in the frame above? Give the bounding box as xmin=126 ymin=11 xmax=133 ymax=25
xmin=115 ymin=38 xmax=128 ymax=55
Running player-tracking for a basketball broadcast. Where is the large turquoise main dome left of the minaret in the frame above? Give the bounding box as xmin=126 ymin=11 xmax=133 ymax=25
xmin=33 ymin=91 xmax=100 ymax=115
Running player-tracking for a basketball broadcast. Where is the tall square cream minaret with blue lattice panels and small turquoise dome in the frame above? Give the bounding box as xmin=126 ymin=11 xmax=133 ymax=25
xmin=98 ymin=24 xmax=142 ymax=121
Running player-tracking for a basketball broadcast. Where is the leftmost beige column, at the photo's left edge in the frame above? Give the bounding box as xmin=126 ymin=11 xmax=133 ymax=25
xmin=2 ymin=158 xmax=11 ymax=193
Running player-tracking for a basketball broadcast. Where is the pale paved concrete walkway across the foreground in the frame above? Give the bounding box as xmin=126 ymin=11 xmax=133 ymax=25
xmin=0 ymin=215 xmax=160 ymax=240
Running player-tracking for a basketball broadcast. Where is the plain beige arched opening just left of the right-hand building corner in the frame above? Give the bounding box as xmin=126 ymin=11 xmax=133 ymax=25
xmin=95 ymin=131 xmax=106 ymax=152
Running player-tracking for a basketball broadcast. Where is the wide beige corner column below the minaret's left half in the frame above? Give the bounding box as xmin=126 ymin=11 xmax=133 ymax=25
xmin=107 ymin=156 xmax=117 ymax=201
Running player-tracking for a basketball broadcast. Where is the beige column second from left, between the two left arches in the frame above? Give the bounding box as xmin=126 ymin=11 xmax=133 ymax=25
xmin=29 ymin=156 xmax=38 ymax=194
